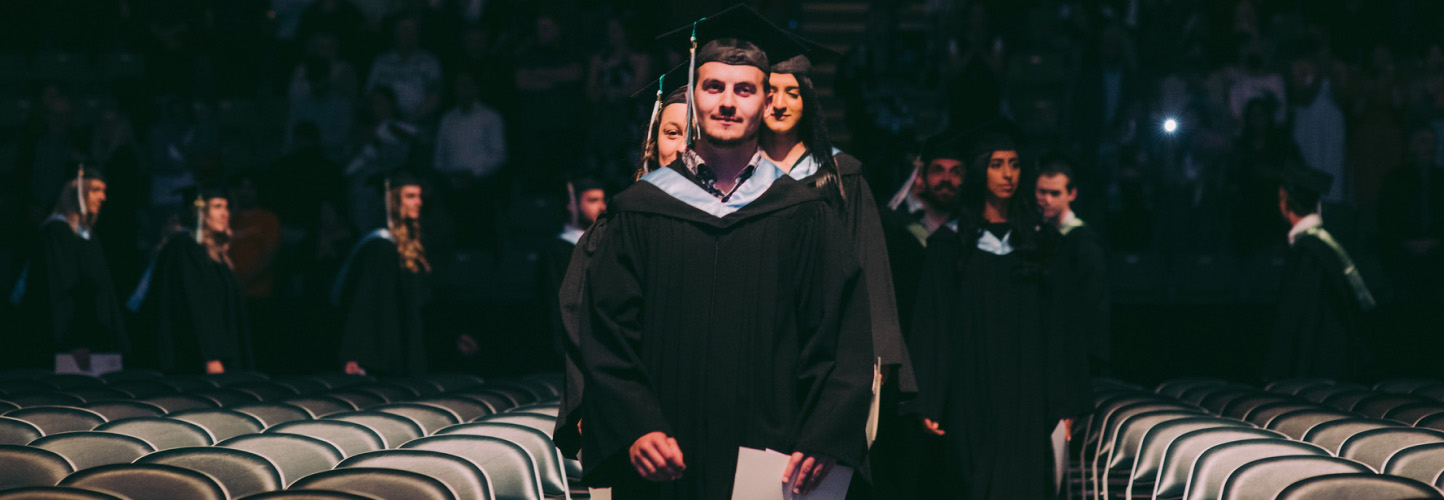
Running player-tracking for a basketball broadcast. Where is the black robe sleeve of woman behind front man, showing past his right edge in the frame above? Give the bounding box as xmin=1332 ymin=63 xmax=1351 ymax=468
xmin=839 ymin=164 xmax=917 ymax=393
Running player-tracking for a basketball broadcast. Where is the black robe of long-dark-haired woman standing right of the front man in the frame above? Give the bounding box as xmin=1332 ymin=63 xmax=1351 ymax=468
xmin=910 ymin=228 xmax=1090 ymax=500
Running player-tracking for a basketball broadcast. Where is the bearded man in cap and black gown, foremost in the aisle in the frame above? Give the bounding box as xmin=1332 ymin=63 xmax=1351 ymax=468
xmin=580 ymin=6 xmax=872 ymax=499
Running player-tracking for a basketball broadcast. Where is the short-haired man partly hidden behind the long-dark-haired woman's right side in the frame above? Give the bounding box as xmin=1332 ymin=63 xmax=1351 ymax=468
xmin=1034 ymin=153 xmax=1113 ymax=376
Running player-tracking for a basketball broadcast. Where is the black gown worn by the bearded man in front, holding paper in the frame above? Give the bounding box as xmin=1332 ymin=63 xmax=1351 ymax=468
xmin=580 ymin=165 xmax=872 ymax=499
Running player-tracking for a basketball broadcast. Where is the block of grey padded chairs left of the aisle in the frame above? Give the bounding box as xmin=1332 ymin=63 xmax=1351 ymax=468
xmin=0 ymin=371 xmax=571 ymax=500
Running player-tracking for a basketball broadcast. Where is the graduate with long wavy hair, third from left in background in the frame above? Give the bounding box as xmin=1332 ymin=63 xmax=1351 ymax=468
xmin=331 ymin=171 xmax=432 ymax=374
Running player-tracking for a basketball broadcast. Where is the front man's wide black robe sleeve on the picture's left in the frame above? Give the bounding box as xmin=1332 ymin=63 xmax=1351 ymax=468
xmin=579 ymin=214 xmax=674 ymax=477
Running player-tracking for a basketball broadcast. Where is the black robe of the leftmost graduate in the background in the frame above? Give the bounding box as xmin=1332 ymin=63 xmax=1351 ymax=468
xmin=19 ymin=218 xmax=130 ymax=367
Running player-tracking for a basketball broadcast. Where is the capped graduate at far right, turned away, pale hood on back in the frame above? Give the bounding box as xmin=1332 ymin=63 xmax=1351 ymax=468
xmin=1264 ymin=166 xmax=1375 ymax=380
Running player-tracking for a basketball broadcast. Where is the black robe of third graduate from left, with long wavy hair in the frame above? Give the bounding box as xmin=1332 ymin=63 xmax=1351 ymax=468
xmin=336 ymin=231 xmax=427 ymax=376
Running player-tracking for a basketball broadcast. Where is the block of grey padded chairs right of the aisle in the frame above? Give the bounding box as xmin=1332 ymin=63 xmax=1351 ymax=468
xmin=1069 ymin=379 xmax=1444 ymax=500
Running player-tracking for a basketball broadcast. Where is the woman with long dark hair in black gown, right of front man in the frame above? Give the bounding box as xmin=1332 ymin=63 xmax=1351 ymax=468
xmin=910 ymin=136 xmax=1089 ymax=500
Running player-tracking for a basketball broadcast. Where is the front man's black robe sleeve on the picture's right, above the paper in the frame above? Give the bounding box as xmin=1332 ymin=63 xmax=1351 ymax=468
xmin=794 ymin=205 xmax=874 ymax=467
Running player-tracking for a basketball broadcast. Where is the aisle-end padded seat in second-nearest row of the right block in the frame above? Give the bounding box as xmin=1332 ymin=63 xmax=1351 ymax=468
xmin=1219 ymin=455 xmax=1372 ymax=500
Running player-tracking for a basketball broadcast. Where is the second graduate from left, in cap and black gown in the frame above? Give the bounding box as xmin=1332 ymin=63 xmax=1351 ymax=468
xmin=129 ymin=188 xmax=253 ymax=373
